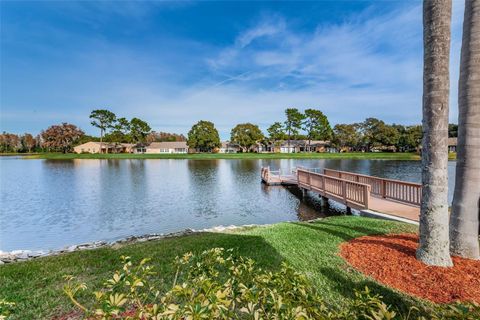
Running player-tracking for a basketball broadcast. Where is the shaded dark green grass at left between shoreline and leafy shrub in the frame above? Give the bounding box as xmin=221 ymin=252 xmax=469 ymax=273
xmin=0 ymin=233 xmax=283 ymax=319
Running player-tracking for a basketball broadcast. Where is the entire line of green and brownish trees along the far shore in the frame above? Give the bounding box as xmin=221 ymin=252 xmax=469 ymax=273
xmin=0 ymin=108 xmax=458 ymax=153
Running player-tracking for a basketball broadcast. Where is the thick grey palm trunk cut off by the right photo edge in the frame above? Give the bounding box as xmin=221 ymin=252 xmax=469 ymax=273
xmin=450 ymin=0 xmax=480 ymax=259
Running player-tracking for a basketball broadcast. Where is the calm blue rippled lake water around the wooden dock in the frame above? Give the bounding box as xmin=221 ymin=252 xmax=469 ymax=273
xmin=0 ymin=157 xmax=455 ymax=251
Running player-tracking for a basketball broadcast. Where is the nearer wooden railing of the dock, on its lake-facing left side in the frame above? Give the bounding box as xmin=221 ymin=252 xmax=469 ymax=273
xmin=297 ymin=168 xmax=370 ymax=210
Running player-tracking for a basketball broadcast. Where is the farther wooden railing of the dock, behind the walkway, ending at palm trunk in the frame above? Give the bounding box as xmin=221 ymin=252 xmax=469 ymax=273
xmin=323 ymin=169 xmax=422 ymax=206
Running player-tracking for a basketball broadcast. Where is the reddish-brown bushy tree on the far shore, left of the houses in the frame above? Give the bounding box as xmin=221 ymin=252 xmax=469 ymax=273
xmin=41 ymin=123 xmax=84 ymax=153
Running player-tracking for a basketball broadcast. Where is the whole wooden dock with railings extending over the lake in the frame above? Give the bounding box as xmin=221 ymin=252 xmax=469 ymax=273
xmin=261 ymin=167 xmax=422 ymax=222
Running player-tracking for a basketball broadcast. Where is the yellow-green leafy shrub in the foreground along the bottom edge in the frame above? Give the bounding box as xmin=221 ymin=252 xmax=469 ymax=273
xmin=64 ymin=248 xmax=476 ymax=320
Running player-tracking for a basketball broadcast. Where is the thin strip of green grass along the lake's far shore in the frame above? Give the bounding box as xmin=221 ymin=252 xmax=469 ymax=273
xmin=18 ymin=152 xmax=426 ymax=160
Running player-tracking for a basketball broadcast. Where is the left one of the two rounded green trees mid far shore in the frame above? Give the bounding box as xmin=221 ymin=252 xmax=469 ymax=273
xmin=187 ymin=120 xmax=221 ymax=152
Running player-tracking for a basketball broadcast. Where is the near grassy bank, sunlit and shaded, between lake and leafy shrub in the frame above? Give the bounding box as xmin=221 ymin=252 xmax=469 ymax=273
xmin=0 ymin=217 xmax=438 ymax=319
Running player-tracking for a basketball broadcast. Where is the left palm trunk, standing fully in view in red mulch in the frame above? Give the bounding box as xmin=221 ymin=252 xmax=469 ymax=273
xmin=417 ymin=0 xmax=452 ymax=267
